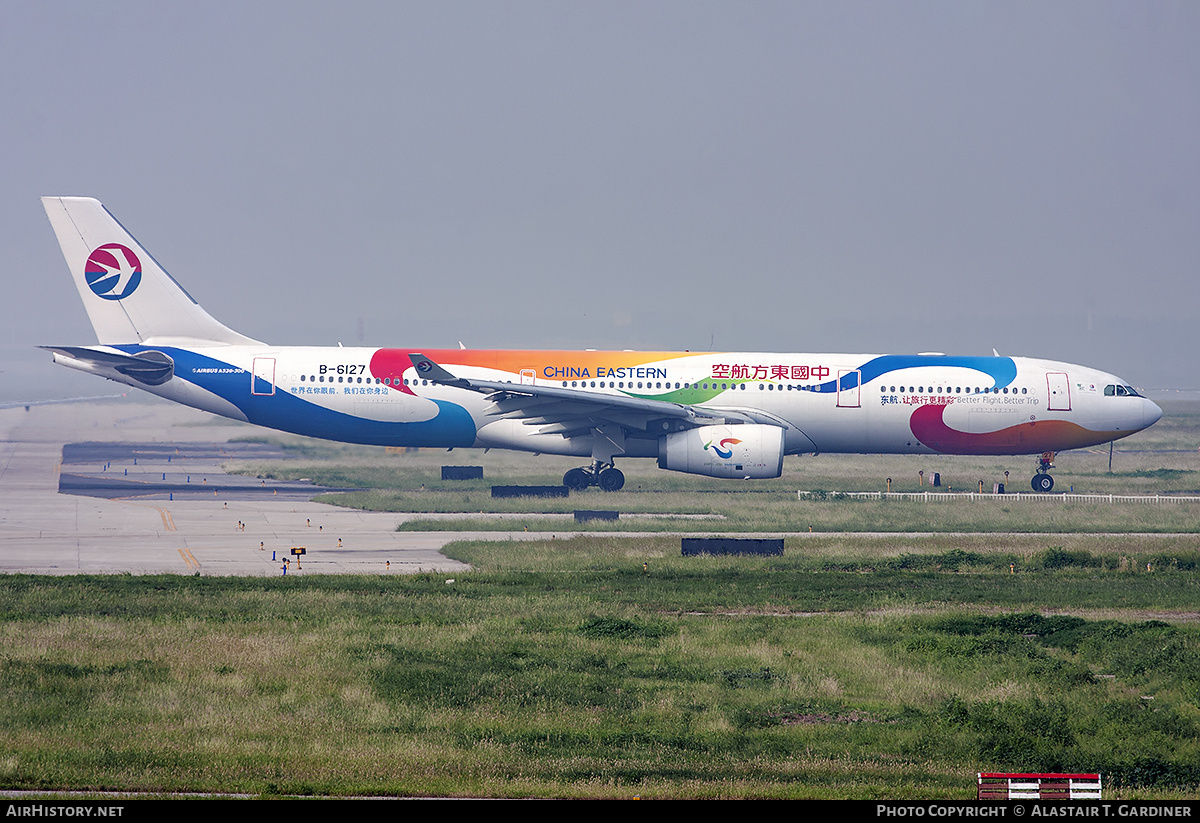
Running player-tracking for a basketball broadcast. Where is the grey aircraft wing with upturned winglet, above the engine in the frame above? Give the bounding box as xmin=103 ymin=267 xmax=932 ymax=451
xmin=410 ymin=354 xmax=772 ymax=437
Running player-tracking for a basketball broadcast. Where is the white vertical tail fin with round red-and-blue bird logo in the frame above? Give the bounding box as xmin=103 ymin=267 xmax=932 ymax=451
xmin=42 ymin=197 xmax=259 ymax=346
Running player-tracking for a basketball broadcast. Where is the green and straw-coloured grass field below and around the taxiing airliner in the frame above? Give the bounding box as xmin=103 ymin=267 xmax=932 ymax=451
xmin=0 ymin=395 xmax=1200 ymax=799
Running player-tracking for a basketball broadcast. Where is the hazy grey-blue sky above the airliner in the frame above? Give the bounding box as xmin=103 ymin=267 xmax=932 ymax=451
xmin=0 ymin=0 xmax=1200 ymax=400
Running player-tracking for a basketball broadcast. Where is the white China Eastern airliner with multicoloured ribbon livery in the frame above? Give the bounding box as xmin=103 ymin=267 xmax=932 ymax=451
xmin=41 ymin=197 xmax=1163 ymax=492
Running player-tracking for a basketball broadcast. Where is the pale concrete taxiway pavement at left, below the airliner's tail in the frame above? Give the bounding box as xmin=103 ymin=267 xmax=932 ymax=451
xmin=0 ymin=397 xmax=484 ymax=576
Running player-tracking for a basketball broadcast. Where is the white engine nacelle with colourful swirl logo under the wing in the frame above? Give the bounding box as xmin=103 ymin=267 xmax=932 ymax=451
xmin=659 ymin=423 xmax=784 ymax=480
